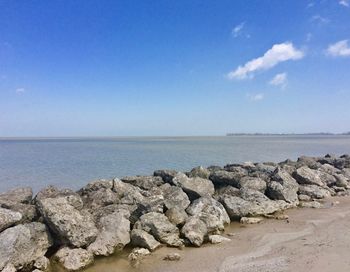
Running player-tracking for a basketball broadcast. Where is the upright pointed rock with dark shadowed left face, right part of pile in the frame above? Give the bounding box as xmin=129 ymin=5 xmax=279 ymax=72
xmin=266 ymin=168 xmax=299 ymax=205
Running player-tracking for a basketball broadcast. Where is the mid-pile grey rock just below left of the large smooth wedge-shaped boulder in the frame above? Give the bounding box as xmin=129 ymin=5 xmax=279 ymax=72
xmin=161 ymin=184 xmax=191 ymax=210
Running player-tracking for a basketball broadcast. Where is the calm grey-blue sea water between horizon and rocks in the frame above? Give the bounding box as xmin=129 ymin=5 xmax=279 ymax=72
xmin=0 ymin=136 xmax=350 ymax=192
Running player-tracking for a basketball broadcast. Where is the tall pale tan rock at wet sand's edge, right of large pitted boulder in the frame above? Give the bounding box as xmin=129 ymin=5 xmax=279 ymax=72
xmin=88 ymin=210 xmax=130 ymax=256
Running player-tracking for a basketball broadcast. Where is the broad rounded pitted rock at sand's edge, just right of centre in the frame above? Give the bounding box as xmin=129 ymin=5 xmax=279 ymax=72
xmin=186 ymin=197 xmax=231 ymax=233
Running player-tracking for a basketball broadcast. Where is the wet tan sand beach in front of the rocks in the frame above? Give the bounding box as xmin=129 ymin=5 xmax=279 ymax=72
xmin=84 ymin=197 xmax=350 ymax=272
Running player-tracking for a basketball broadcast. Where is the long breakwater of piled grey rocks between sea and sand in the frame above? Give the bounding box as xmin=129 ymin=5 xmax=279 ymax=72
xmin=0 ymin=155 xmax=350 ymax=272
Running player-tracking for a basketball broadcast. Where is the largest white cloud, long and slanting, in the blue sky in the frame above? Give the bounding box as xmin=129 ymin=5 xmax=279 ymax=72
xmin=227 ymin=42 xmax=304 ymax=79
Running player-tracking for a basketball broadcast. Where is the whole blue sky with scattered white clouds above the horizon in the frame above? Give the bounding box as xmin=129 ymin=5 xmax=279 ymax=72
xmin=0 ymin=0 xmax=350 ymax=137
